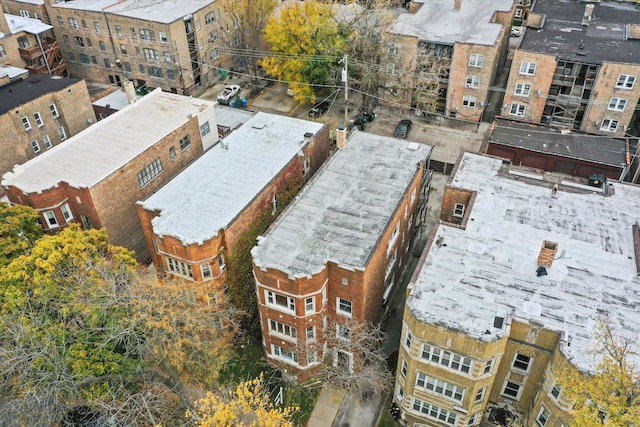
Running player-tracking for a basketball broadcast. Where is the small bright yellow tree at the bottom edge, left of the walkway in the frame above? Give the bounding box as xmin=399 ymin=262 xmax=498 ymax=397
xmin=187 ymin=375 xmax=298 ymax=427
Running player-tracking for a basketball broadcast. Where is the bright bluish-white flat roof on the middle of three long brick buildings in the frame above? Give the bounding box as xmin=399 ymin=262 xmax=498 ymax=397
xmin=138 ymin=113 xmax=324 ymax=245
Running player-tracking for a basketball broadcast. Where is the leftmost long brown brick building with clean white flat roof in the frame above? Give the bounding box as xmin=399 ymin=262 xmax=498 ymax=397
xmin=2 ymin=89 xmax=218 ymax=261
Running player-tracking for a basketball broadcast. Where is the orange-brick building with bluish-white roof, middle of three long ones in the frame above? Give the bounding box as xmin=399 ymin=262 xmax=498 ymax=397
xmin=138 ymin=113 xmax=330 ymax=296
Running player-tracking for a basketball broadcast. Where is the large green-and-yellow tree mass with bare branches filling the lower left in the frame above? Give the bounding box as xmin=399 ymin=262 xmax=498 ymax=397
xmin=0 ymin=225 xmax=236 ymax=426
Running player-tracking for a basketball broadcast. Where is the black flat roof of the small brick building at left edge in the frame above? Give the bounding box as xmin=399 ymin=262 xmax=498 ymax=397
xmin=0 ymin=74 xmax=80 ymax=114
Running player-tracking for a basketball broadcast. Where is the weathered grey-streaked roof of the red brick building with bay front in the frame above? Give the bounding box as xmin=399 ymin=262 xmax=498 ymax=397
xmin=251 ymin=131 xmax=431 ymax=278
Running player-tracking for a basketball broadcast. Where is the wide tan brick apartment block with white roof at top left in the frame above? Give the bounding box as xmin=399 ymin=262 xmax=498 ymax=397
xmin=48 ymin=0 xmax=233 ymax=95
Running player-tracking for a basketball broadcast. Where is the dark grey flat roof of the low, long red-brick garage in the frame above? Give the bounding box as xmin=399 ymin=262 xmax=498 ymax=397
xmin=490 ymin=120 xmax=627 ymax=167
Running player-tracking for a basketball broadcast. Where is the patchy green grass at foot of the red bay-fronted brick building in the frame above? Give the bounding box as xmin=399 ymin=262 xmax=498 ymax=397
xmin=220 ymin=340 xmax=320 ymax=426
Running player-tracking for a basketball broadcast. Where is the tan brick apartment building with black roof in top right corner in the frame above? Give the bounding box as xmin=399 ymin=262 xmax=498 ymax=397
xmin=501 ymin=0 xmax=640 ymax=137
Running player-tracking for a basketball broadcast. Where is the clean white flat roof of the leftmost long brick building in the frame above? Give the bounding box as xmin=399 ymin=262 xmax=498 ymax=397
xmin=2 ymin=89 xmax=214 ymax=193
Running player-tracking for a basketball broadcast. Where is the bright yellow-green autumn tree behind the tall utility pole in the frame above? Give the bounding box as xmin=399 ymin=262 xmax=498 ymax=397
xmin=262 ymin=0 xmax=348 ymax=102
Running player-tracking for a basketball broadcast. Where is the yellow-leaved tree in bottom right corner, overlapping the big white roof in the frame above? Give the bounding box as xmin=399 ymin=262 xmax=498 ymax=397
xmin=558 ymin=322 xmax=640 ymax=427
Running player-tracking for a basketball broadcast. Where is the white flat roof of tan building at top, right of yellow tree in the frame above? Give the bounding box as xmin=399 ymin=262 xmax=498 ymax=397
xmin=389 ymin=0 xmax=513 ymax=46
